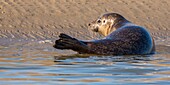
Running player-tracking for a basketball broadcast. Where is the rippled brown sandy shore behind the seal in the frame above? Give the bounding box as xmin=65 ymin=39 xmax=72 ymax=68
xmin=0 ymin=0 xmax=170 ymax=39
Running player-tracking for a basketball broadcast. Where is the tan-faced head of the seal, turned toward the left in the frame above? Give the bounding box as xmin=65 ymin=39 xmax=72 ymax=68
xmin=89 ymin=13 xmax=126 ymax=36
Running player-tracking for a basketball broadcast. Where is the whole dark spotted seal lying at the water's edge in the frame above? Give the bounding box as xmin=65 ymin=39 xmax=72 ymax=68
xmin=54 ymin=13 xmax=155 ymax=55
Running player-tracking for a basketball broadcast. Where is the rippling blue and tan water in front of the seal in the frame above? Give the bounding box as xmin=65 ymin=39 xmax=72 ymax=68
xmin=0 ymin=40 xmax=170 ymax=85
